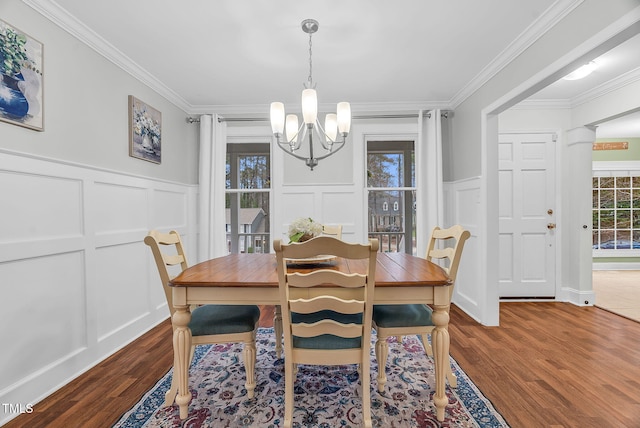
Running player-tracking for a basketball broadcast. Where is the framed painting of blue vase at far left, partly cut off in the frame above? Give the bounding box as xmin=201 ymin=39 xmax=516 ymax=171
xmin=0 ymin=20 xmax=44 ymax=131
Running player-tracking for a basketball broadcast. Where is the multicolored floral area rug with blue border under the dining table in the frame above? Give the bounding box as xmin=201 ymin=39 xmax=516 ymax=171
xmin=114 ymin=328 xmax=508 ymax=428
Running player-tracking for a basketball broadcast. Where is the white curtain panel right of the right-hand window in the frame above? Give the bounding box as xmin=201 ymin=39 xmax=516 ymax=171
xmin=416 ymin=110 xmax=447 ymax=257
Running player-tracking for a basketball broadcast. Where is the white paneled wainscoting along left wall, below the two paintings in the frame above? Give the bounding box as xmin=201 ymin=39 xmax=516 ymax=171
xmin=0 ymin=150 xmax=197 ymax=425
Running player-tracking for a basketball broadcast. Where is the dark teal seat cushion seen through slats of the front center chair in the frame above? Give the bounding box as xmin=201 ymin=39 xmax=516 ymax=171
xmin=291 ymin=311 xmax=362 ymax=349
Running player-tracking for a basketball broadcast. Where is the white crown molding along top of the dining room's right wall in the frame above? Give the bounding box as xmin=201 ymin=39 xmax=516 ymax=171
xmin=449 ymin=0 xmax=584 ymax=108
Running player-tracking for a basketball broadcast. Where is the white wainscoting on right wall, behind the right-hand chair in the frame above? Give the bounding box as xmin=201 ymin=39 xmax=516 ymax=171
xmin=443 ymin=178 xmax=485 ymax=320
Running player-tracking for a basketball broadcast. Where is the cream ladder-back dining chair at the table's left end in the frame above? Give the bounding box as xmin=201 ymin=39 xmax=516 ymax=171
xmin=144 ymin=230 xmax=260 ymax=406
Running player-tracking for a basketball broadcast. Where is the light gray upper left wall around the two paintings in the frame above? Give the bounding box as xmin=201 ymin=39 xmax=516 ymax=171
xmin=0 ymin=0 xmax=198 ymax=184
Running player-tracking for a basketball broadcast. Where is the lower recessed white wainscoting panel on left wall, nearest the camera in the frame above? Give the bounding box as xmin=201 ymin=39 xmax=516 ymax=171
xmin=0 ymin=252 xmax=87 ymax=392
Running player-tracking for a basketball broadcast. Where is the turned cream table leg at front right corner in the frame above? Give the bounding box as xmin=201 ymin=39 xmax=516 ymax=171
xmin=431 ymin=305 xmax=449 ymax=422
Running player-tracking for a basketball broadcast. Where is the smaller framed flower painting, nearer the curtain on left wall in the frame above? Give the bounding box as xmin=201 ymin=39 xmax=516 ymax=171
xmin=129 ymin=95 xmax=162 ymax=163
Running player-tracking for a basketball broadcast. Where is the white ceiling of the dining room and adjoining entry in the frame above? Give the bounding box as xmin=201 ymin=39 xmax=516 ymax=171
xmin=24 ymin=0 xmax=640 ymax=135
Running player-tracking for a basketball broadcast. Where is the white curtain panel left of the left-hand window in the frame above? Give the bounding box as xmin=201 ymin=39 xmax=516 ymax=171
xmin=198 ymin=115 xmax=227 ymax=261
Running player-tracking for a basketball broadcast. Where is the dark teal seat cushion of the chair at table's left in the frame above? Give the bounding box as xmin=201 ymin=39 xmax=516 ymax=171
xmin=189 ymin=305 xmax=260 ymax=336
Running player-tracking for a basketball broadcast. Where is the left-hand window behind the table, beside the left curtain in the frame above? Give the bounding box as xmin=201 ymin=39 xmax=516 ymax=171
xmin=225 ymin=143 xmax=271 ymax=253
